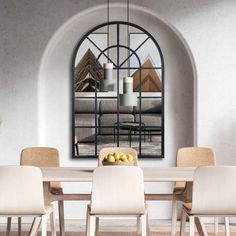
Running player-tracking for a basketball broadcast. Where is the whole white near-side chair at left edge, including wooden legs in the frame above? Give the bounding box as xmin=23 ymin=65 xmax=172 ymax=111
xmin=0 ymin=166 xmax=56 ymax=236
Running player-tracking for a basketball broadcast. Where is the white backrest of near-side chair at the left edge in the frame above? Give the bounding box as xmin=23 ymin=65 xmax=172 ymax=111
xmin=0 ymin=166 xmax=45 ymax=215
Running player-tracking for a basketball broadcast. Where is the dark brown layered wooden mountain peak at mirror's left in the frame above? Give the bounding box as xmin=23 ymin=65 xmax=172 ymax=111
xmin=74 ymin=49 xmax=103 ymax=92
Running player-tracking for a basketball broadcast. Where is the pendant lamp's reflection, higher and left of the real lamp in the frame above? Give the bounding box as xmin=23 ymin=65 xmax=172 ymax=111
xmin=99 ymin=63 xmax=116 ymax=92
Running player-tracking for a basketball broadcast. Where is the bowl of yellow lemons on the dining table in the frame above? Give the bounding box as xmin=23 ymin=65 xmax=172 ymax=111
xmin=102 ymin=152 xmax=134 ymax=166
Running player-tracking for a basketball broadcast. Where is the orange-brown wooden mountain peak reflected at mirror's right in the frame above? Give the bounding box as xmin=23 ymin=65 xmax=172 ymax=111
xmin=132 ymin=59 xmax=162 ymax=92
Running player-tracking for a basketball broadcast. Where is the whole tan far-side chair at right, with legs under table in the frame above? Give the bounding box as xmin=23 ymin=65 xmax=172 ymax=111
xmin=171 ymin=147 xmax=227 ymax=236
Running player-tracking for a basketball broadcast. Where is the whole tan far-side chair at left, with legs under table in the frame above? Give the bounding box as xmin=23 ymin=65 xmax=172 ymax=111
xmin=8 ymin=147 xmax=65 ymax=236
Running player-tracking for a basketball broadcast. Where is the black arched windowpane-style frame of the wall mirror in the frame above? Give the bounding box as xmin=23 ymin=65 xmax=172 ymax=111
xmin=71 ymin=21 xmax=165 ymax=159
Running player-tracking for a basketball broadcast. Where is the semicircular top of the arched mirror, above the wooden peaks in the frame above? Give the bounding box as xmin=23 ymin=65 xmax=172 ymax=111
xmin=73 ymin=21 xmax=164 ymax=71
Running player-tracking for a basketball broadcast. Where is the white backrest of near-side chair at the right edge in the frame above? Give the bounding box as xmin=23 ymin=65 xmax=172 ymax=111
xmin=191 ymin=166 xmax=236 ymax=215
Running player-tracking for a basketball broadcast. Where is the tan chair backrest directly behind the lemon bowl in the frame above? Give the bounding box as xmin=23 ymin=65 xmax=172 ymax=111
xmin=98 ymin=147 xmax=138 ymax=166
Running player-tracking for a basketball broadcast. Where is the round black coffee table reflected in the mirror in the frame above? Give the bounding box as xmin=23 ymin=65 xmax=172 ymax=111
xmin=113 ymin=121 xmax=145 ymax=147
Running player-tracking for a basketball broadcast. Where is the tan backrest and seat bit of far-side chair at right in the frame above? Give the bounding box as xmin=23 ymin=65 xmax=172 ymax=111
xmin=175 ymin=147 xmax=216 ymax=188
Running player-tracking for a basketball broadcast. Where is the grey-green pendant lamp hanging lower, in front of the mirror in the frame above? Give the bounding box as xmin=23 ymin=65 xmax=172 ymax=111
xmin=119 ymin=77 xmax=137 ymax=106
